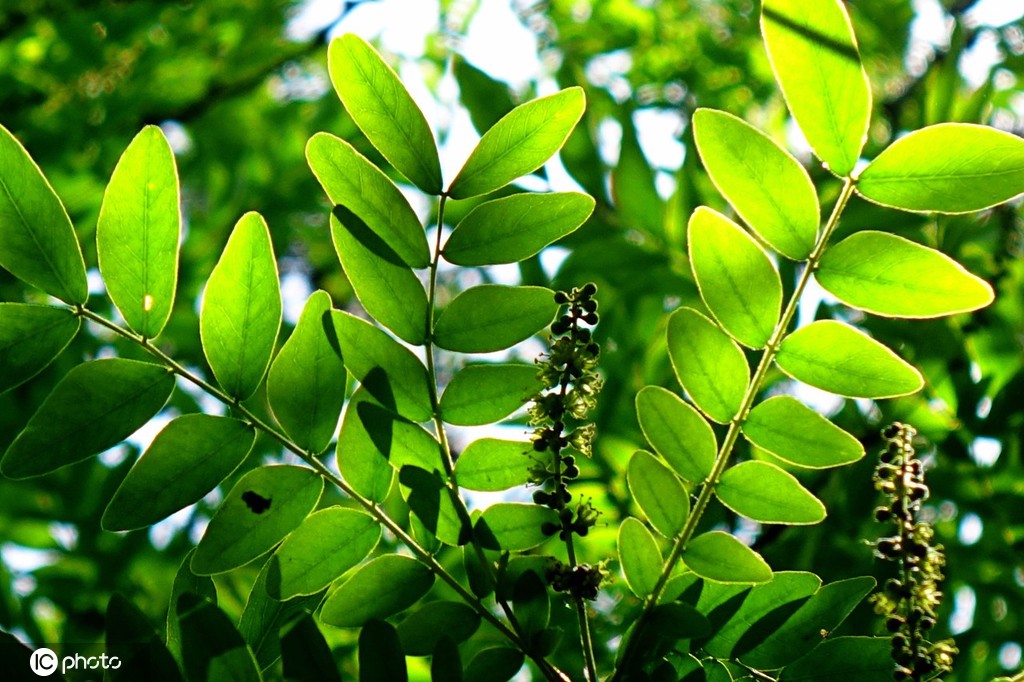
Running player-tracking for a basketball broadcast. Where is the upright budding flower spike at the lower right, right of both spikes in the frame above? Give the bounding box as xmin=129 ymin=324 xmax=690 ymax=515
xmin=871 ymin=422 xmax=956 ymax=682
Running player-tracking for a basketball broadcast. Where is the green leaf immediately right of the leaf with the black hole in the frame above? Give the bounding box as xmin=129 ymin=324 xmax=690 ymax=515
xmin=266 ymin=507 xmax=381 ymax=600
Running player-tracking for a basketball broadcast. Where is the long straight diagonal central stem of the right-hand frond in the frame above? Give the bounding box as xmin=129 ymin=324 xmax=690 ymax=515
xmin=609 ymin=178 xmax=854 ymax=682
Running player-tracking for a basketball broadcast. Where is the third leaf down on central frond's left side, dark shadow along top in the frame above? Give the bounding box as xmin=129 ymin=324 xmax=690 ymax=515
xmin=331 ymin=206 xmax=427 ymax=345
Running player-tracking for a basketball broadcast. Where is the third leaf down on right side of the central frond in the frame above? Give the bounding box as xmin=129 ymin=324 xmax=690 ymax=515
xmin=434 ymin=285 xmax=558 ymax=353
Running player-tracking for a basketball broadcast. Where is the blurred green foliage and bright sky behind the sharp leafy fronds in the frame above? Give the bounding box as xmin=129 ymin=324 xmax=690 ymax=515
xmin=0 ymin=0 xmax=1024 ymax=681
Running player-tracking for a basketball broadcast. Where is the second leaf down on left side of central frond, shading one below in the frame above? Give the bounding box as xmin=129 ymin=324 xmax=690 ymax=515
xmin=306 ymin=132 xmax=430 ymax=267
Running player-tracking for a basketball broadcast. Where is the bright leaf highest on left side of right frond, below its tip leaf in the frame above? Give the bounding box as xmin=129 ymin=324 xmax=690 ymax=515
xmin=693 ymin=109 xmax=820 ymax=259
